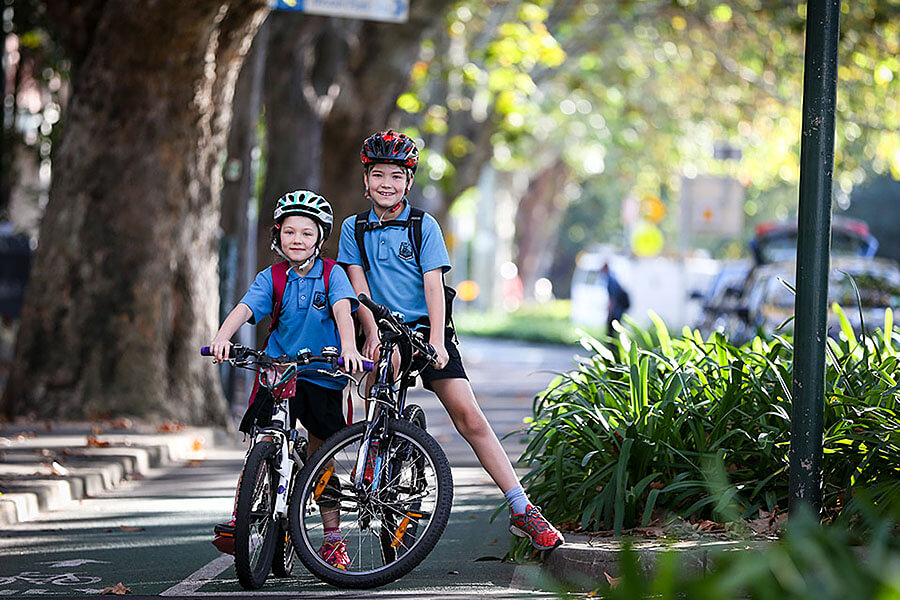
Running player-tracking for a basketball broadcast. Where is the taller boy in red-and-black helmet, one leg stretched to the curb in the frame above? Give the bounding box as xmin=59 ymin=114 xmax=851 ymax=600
xmin=337 ymin=130 xmax=564 ymax=550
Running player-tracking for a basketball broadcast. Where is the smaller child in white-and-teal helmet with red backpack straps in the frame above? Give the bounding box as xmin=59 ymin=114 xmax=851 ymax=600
xmin=210 ymin=191 xmax=363 ymax=569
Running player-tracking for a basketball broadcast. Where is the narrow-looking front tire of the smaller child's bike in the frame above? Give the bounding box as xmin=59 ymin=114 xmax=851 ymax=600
xmin=234 ymin=442 xmax=278 ymax=590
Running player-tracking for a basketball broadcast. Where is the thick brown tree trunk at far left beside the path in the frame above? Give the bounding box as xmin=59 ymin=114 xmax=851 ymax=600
xmin=4 ymin=0 xmax=266 ymax=423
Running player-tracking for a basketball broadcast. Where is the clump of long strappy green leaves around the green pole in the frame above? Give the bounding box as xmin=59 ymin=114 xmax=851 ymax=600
xmin=522 ymin=311 xmax=900 ymax=533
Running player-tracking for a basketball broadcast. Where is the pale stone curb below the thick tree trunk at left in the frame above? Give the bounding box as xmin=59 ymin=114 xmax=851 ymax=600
xmin=0 ymin=423 xmax=228 ymax=526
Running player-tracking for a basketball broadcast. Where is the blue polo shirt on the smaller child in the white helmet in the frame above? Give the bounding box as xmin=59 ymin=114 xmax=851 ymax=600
xmin=241 ymin=259 xmax=359 ymax=389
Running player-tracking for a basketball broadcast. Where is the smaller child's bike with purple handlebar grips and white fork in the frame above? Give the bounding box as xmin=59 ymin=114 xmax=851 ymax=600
xmin=200 ymin=345 xmax=373 ymax=590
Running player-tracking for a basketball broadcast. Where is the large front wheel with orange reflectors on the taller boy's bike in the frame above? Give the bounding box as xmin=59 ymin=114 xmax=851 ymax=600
xmin=289 ymin=419 xmax=453 ymax=589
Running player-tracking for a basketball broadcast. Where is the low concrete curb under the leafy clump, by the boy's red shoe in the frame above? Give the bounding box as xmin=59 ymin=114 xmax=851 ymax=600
xmin=541 ymin=533 xmax=770 ymax=591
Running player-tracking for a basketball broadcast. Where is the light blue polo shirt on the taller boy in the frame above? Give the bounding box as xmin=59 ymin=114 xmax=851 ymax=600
xmin=337 ymin=203 xmax=450 ymax=323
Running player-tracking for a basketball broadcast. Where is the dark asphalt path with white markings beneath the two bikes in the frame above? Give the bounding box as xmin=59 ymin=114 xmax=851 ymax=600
xmin=0 ymin=339 xmax=573 ymax=598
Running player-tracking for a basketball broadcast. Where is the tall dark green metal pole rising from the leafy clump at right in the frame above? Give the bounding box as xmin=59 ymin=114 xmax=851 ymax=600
xmin=789 ymin=0 xmax=841 ymax=512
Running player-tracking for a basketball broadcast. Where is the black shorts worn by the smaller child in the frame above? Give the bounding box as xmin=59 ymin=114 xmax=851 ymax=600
xmin=238 ymin=380 xmax=347 ymax=440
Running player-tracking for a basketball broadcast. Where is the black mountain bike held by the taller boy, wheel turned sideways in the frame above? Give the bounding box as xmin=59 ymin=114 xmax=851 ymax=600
xmin=289 ymin=294 xmax=453 ymax=588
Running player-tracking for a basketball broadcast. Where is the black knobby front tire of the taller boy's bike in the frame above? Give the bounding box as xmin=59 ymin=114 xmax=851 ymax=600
xmin=289 ymin=419 xmax=453 ymax=589
